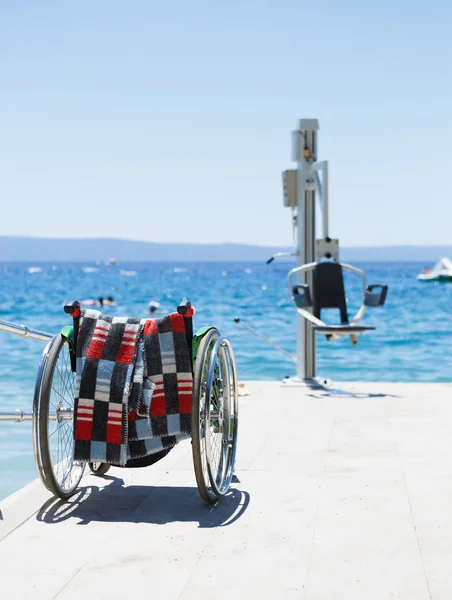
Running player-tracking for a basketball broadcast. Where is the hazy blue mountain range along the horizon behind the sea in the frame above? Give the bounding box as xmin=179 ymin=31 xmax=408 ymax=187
xmin=0 ymin=236 xmax=452 ymax=262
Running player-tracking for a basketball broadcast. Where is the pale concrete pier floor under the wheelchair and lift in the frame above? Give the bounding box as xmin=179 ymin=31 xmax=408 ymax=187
xmin=0 ymin=382 xmax=452 ymax=600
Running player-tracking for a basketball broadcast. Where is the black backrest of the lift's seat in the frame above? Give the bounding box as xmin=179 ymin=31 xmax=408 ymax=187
xmin=312 ymin=262 xmax=348 ymax=325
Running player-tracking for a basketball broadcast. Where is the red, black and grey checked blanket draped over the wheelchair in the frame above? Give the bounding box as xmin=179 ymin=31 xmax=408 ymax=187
xmin=74 ymin=310 xmax=193 ymax=466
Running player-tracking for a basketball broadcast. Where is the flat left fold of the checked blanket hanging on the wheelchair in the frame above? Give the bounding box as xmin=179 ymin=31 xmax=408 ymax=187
xmin=74 ymin=310 xmax=142 ymax=465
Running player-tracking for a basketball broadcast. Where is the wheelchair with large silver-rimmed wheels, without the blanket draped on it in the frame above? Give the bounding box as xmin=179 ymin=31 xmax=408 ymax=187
xmin=32 ymin=301 xmax=238 ymax=504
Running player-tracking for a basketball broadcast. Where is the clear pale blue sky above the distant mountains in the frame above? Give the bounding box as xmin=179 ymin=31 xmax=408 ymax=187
xmin=0 ymin=0 xmax=452 ymax=246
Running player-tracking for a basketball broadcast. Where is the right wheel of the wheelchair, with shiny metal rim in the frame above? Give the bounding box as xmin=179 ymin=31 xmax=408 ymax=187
xmin=192 ymin=329 xmax=238 ymax=504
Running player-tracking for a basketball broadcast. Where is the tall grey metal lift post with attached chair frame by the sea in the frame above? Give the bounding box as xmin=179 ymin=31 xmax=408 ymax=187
xmin=267 ymin=119 xmax=388 ymax=386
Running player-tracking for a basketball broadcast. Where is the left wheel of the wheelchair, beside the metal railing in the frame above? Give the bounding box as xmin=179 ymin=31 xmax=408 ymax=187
xmin=33 ymin=334 xmax=85 ymax=499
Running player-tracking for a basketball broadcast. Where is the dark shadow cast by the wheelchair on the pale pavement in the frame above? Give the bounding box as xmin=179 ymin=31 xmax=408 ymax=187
xmin=36 ymin=475 xmax=250 ymax=528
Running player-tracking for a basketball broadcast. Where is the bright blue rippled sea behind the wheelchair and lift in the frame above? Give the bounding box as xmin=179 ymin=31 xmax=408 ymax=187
xmin=0 ymin=261 xmax=452 ymax=498
